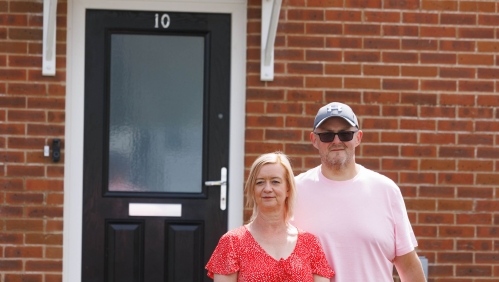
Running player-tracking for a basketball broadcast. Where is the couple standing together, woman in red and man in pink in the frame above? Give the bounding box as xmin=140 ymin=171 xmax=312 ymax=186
xmin=206 ymin=102 xmax=426 ymax=282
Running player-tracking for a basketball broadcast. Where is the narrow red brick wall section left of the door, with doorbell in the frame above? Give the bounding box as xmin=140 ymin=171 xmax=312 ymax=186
xmin=0 ymin=0 xmax=67 ymax=282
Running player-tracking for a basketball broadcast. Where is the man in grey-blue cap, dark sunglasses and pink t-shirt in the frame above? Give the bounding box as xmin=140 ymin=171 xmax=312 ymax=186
xmin=293 ymin=102 xmax=426 ymax=282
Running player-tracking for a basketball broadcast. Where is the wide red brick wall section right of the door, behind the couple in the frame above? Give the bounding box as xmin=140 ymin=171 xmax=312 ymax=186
xmin=245 ymin=0 xmax=499 ymax=282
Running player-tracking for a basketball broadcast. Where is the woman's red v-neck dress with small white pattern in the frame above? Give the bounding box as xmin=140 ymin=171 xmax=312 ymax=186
xmin=206 ymin=226 xmax=334 ymax=282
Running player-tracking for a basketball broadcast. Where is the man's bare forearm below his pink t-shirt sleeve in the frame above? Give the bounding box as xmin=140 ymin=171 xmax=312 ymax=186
xmin=393 ymin=251 xmax=426 ymax=282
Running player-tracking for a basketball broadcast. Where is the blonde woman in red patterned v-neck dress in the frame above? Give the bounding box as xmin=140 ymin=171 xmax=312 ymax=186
xmin=206 ymin=153 xmax=334 ymax=282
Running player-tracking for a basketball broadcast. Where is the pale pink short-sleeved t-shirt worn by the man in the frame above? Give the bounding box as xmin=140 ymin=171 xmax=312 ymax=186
xmin=292 ymin=166 xmax=417 ymax=282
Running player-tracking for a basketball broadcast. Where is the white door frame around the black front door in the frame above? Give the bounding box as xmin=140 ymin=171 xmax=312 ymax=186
xmin=63 ymin=0 xmax=247 ymax=282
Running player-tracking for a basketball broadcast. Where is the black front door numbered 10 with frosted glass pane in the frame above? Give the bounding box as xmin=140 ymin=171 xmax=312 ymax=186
xmin=82 ymin=10 xmax=231 ymax=282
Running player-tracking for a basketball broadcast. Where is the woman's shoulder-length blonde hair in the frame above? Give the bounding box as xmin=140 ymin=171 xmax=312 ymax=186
xmin=244 ymin=152 xmax=296 ymax=222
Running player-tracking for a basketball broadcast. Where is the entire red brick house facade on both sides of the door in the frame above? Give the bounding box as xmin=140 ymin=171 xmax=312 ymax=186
xmin=0 ymin=0 xmax=499 ymax=282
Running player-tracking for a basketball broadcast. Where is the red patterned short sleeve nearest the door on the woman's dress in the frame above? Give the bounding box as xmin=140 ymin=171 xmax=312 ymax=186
xmin=205 ymin=231 xmax=240 ymax=279
